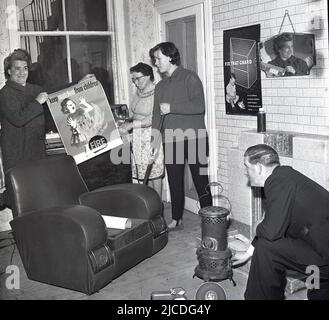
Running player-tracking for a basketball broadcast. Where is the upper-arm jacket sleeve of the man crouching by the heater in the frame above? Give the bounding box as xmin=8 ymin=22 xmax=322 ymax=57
xmin=256 ymin=177 xmax=296 ymax=241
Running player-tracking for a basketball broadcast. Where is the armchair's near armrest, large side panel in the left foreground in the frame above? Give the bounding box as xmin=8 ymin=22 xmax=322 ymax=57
xmin=10 ymin=205 xmax=114 ymax=294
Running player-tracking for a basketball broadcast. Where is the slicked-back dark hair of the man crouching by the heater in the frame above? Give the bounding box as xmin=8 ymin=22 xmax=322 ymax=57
xmin=244 ymin=144 xmax=280 ymax=167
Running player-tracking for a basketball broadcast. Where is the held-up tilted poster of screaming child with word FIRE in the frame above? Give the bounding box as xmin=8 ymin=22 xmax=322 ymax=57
xmin=47 ymin=77 xmax=122 ymax=164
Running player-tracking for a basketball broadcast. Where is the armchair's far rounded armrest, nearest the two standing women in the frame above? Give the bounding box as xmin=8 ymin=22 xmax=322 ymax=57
xmin=79 ymin=183 xmax=162 ymax=219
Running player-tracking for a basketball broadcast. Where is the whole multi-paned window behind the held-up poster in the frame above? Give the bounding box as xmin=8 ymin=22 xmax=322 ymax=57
xmin=16 ymin=0 xmax=114 ymax=129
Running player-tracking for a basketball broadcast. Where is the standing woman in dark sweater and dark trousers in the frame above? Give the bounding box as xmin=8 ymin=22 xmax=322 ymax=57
xmin=150 ymin=42 xmax=212 ymax=229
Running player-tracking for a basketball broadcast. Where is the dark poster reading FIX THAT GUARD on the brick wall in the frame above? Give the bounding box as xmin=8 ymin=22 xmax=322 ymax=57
xmin=224 ymin=24 xmax=262 ymax=115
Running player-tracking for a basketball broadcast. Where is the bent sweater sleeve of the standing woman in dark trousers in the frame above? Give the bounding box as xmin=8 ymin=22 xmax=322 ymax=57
xmin=170 ymin=73 xmax=205 ymax=115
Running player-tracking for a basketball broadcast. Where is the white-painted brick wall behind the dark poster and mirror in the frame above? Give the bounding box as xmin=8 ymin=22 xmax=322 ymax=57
xmin=213 ymin=0 xmax=329 ymax=192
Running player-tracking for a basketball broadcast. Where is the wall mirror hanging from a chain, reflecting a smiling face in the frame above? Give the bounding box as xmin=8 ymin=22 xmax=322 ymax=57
xmin=259 ymin=32 xmax=316 ymax=78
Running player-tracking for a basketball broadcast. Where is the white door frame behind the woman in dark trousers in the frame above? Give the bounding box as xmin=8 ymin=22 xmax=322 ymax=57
xmin=154 ymin=0 xmax=218 ymax=213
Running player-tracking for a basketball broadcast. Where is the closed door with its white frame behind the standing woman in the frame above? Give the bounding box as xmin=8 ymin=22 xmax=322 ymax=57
xmin=157 ymin=0 xmax=217 ymax=213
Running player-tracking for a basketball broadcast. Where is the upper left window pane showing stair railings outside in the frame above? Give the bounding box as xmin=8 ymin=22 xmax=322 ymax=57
xmin=17 ymin=0 xmax=64 ymax=31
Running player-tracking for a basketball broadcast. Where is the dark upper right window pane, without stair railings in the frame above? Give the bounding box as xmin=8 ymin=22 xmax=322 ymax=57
xmin=65 ymin=0 xmax=108 ymax=31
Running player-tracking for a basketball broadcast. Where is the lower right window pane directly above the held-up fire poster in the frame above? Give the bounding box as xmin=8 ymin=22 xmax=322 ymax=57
xmin=70 ymin=36 xmax=114 ymax=103
